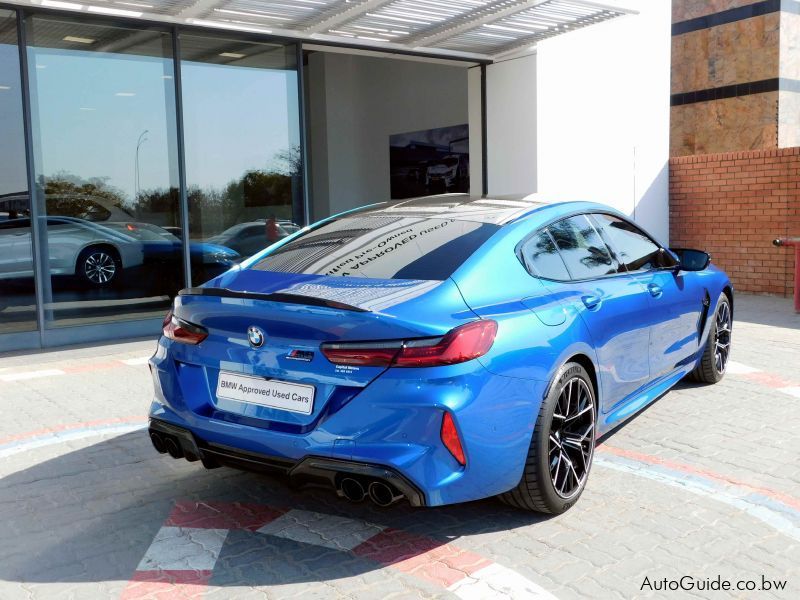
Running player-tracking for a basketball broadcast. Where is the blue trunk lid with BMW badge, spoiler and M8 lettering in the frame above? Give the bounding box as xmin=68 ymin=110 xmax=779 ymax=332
xmin=166 ymin=269 xmax=476 ymax=432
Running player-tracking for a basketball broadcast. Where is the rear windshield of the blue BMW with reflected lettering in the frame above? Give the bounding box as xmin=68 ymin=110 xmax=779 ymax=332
xmin=251 ymin=216 xmax=499 ymax=281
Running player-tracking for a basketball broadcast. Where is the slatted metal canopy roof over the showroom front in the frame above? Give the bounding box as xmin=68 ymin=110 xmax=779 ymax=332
xmin=11 ymin=0 xmax=636 ymax=60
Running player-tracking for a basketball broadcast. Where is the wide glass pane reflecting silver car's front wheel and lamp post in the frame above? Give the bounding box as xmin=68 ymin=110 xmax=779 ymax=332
xmin=27 ymin=16 xmax=183 ymax=327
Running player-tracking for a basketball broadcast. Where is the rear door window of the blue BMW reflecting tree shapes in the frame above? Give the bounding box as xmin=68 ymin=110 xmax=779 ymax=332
xmin=548 ymin=215 xmax=617 ymax=279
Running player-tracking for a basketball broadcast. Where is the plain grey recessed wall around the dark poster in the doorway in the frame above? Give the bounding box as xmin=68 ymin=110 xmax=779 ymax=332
xmin=306 ymin=52 xmax=472 ymax=220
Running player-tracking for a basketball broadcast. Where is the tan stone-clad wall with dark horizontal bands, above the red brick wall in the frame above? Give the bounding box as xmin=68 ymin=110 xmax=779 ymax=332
xmin=670 ymin=0 xmax=780 ymax=156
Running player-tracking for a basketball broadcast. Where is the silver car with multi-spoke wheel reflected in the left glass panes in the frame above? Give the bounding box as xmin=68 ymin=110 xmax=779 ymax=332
xmin=0 ymin=217 xmax=144 ymax=287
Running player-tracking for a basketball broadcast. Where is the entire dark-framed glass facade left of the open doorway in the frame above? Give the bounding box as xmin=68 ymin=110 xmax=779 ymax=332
xmin=0 ymin=8 xmax=304 ymax=351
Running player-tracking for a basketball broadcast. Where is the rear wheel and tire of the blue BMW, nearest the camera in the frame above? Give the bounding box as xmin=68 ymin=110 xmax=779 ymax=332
xmin=500 ymin=362 xmax=597 ymax=515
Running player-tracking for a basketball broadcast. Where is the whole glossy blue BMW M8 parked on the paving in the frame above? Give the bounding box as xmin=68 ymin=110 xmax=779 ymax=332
xmin=149 ymin=194 xmax=733 ymax=513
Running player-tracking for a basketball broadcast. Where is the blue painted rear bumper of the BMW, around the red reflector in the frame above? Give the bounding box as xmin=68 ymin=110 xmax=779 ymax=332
xmin=150 ymin=352 xmax=546 ymax=506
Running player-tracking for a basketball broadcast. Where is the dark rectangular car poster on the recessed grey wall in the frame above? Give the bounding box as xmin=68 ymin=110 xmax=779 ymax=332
xmin=389 ymin=123 xmax=469 ymax=200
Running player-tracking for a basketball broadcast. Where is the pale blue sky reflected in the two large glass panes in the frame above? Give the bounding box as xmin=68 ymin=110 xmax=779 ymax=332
xmin=27 ymin=47 xmax=299 ymax=200
